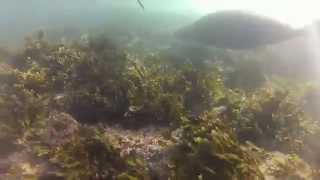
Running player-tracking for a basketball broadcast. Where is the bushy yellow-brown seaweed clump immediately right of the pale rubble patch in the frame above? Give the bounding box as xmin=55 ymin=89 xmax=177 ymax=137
xmin=171 ymin=111 xmax=264 ymax=180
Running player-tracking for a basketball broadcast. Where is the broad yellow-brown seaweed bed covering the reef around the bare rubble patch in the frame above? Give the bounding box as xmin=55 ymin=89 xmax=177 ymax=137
xmin=0 ymin=35 xmax=320 ymax=180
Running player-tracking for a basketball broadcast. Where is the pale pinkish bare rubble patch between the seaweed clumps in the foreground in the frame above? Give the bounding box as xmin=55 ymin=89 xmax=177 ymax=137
xmin=105 ymin=126 xmax=173 ymax=179
